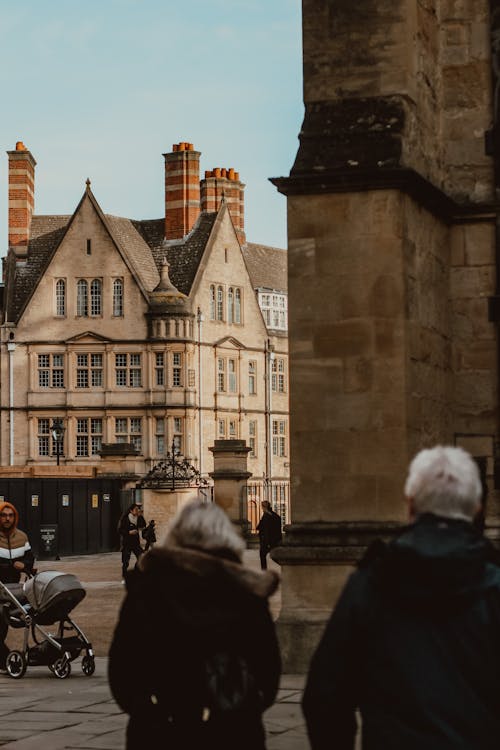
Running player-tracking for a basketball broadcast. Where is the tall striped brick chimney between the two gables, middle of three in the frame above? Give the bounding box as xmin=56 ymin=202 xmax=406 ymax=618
xmin=163 ymin=143 xmax=201 ymax=240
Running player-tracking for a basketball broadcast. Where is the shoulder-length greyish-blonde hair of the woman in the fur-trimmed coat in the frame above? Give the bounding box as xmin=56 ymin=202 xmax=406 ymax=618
xmin=164 ymin=500 xmax=246 ymax=560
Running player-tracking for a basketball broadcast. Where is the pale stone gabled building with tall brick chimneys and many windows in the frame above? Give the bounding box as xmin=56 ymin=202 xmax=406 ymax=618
xmin=0 ymin=142 xmax=289 ymax=528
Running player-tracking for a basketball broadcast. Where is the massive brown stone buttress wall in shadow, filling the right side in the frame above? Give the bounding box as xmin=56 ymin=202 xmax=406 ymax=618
xmin=273 ymin=0 xmax=500 ymax=671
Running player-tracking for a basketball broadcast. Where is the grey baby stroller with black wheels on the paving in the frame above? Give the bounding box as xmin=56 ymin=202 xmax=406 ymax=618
xmin=0 ymin=570 xmax=95 ymax=680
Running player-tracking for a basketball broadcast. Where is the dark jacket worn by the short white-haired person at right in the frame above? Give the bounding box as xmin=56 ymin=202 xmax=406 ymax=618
xmin=303 ymin=515 xmax=500 ymax=750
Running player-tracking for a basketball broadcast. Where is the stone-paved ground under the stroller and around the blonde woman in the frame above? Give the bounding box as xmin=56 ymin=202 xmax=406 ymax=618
xmin=0 ymin=550 xmax=309 ymax=750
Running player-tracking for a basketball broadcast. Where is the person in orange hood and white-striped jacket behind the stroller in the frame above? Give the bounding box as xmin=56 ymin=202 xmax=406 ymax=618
xmin=0 ymin=503 xmax=35 ymax=669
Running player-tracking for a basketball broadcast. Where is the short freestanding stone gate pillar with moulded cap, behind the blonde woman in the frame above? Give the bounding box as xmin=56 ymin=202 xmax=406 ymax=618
xmin=208 ymin=440 xmax=252 ymax=536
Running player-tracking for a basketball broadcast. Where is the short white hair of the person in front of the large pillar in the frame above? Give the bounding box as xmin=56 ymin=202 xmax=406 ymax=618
xmin=405 ymin=445 xmax=482 ymax=521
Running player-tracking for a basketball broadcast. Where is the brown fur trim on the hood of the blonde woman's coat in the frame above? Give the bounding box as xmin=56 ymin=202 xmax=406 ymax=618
xmin=138 ymin=546 xmax=280 ymax=599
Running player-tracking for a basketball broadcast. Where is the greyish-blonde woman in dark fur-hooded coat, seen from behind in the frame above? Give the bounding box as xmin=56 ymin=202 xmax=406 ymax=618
xmin=109 ymin=502 xmax=281 ymax=750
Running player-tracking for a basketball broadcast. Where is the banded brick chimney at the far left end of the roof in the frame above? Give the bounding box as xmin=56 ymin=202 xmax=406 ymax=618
xmin=7 ymin=141 xmax=36 ymax=260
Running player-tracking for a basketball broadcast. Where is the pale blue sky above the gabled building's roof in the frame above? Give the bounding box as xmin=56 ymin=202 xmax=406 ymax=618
xmin=0 ymin=0 xmax=303 ymax=255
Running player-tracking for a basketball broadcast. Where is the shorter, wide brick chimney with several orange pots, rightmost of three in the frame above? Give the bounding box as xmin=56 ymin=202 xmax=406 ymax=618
xmin=200 ymin=167 xmax=246 ymax=245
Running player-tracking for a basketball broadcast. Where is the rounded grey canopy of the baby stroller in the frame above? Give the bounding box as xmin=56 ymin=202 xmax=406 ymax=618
xmin=23 ymin=570 xmax=85 ymax=616
